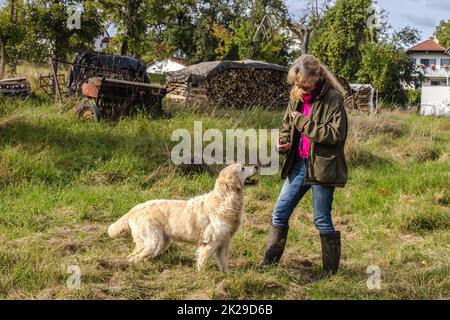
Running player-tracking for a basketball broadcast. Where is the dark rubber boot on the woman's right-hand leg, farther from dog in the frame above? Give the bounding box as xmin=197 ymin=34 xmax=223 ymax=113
xmin=320 ymin=231 xmax=341 ymax=276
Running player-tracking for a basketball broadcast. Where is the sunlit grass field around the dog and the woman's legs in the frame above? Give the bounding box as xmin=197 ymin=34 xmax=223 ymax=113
xmin=0 ymin=93 xmax=450 ymax=299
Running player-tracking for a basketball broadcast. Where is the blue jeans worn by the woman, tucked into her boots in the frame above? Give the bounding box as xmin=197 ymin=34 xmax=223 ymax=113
xmin=272 ymin=157 xmax=335 ymax=234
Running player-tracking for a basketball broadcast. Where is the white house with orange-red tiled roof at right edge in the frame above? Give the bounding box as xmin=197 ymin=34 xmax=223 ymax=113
xmin=407 ymin=39 xmax=450 ymax=86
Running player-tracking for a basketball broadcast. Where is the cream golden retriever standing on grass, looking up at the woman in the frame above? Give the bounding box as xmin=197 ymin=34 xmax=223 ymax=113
xmin=108 ymin=164 xmax=259 ymax=272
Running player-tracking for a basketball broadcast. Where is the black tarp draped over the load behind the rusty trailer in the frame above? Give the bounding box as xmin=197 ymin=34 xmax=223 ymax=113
xmin=68 ymin=52 xmax=150 ymax=93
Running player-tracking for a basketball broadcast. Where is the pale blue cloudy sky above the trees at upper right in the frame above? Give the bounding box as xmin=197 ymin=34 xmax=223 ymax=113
xmin=286 ymin=0 xmax=450 ymax=40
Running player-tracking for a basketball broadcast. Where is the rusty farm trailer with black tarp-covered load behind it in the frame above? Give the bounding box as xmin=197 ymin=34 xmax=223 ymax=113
xmin=49 ymin=52 xmax=167 ymax=121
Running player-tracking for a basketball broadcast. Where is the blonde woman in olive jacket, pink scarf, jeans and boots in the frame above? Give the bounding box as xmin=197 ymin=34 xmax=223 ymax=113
xmin=262 ymin=54 xmax=347 ymax=275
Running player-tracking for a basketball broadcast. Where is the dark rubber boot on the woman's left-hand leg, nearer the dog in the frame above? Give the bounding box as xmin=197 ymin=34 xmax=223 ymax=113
xmin=259 ymin=223 xmax=289 ymax=269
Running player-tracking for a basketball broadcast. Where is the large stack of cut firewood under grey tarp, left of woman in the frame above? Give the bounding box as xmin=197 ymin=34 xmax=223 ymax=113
xmin=167 ymin=62 xmax=290 ymax=109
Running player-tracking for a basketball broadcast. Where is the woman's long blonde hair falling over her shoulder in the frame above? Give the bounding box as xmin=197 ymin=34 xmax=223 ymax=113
xmin=288 ymin=54 xmax=346 ymax=101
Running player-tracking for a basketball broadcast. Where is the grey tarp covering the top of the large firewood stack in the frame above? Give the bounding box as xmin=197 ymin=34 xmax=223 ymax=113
xmin=167 ymin=60 xmax=289 ymax=85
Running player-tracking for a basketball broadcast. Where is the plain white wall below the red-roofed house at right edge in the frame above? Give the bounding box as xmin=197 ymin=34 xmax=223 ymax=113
xmin=420 ymin=87 xmax=450 ymax=117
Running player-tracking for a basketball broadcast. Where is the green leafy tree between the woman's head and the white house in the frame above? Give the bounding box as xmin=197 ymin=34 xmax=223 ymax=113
xmin=312 ymin=0 xmax=420 ymax=104
